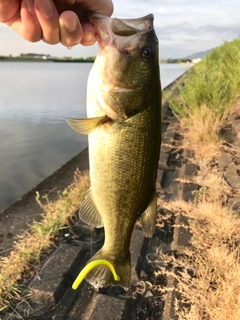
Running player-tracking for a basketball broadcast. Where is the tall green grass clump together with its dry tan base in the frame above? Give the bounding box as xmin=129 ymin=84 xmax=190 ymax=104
xmin=170 ymin=39 xmax=240 ymax=159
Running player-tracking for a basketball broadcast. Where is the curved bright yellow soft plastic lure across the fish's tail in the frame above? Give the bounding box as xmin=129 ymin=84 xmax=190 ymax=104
xmin=72 ymin=259 xmax=120 ymax=290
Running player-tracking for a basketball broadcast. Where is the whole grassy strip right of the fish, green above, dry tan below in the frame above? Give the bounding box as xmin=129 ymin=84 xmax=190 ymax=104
xmin=167 ymin=39 xmax=240 ymax=320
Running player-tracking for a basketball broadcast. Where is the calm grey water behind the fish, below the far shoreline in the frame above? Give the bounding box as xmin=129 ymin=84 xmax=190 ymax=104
xmin=0 ymin=62 xmax=189 ymax=211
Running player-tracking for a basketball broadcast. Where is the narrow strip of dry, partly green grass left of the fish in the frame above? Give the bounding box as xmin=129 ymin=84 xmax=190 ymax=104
xmin=0 ymin=172 xmax=89 ymax=311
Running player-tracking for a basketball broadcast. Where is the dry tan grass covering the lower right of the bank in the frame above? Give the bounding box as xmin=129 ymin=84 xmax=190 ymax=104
xmin=161 ymin=144 xmax=240 ymax=320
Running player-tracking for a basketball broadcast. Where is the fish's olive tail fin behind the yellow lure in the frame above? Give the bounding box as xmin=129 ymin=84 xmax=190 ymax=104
xmin=85 ymin=249 xmax=131 ymax=290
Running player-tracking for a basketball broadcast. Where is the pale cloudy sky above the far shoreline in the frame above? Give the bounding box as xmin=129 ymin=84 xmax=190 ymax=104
xmin=0 ymin=0 xmax=240 ymax=59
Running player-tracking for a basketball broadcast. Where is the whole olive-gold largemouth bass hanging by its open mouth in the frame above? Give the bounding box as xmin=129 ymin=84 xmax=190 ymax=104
xmin=68 ymin=14 xmax=161 ymax=288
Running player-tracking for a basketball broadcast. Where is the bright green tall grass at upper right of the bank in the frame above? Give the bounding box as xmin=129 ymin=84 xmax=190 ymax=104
xmin=170 ymin=39 xmax=240 ymax=125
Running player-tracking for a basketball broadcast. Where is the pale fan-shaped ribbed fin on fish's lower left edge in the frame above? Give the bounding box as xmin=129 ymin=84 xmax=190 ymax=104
xmin=79 ymin=190 xmax=103 ymax=228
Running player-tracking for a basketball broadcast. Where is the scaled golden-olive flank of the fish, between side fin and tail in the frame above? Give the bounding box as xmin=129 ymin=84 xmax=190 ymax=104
xmin=89 ymin=105 xmax=160 ymax=278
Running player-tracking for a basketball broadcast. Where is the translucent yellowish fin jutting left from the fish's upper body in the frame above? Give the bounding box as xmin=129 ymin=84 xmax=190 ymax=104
xmin=66 ymin=116 xmax=109 ymax=134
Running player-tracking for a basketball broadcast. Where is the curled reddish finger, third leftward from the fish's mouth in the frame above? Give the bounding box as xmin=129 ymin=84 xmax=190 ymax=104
xmin=34 ymin=0 xmax=60 ymax=44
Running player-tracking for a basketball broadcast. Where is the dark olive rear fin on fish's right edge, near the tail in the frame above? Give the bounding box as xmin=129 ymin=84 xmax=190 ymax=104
xmin=140 ymin=194 xmax=157 ymax=238
